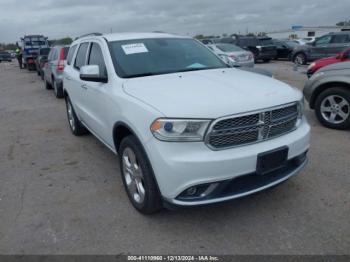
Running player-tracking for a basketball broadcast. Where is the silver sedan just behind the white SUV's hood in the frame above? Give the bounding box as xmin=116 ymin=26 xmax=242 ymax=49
xmin=207 ymin=43 xmax=254 ymax=67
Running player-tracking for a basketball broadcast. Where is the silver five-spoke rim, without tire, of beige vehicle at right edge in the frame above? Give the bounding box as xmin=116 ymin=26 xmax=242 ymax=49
xmin=320 ymin=95 xmax=350 ymax=124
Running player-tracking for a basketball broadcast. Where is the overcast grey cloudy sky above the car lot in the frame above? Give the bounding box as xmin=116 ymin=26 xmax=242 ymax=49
xmin=0 ymin=0 xmax=350 ymax=43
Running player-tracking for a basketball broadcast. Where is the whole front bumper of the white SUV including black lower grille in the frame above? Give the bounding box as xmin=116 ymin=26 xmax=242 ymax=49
xmin=146 ymin=119 xmax=310 ymax=206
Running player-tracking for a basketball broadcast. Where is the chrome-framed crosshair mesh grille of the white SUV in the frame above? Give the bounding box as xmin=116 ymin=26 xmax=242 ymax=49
xmin=206 ymin=103 xmax=299 ymax=149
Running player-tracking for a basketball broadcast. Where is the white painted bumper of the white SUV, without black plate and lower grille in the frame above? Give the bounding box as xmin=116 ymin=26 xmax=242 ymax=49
xmin=145 ymin=119 xmax=310 ymax=206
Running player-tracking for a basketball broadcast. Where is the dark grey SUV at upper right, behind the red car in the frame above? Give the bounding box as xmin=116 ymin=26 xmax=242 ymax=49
xmin=292 ymin=31 xmax=350 ymax=65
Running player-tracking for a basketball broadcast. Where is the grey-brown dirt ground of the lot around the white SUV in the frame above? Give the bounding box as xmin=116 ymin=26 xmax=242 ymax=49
xmin=0 ymin=62 xmax=350 ymax=255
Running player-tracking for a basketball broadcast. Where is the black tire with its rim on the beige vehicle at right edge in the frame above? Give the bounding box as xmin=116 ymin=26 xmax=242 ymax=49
xmin=315 ymin=87 xmax=350 ymax=130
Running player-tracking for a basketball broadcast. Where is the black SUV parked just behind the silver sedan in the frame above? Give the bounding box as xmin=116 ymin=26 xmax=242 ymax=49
xmin=220 ymin=36 xmax=277 ymax=62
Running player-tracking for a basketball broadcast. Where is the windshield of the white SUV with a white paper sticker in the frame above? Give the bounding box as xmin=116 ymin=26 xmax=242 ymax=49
xmin=110 ymin=38 xmax=227 ymax=78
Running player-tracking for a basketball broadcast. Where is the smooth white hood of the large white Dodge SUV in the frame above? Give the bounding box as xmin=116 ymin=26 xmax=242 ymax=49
xmin=123 ymin=68 xmax=302 ymax=118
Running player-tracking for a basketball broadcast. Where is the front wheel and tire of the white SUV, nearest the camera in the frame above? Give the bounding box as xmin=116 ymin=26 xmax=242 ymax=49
xmin=119 ymin=135 xmax=163 ymax=214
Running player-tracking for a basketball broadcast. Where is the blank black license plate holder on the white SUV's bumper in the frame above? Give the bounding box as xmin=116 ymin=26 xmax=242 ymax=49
xmin=256 ymin=146 xmax=289 ymax=175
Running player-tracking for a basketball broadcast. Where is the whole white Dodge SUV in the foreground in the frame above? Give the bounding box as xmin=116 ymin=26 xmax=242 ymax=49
xmin=63 ymin=33 xmax=310 ymax=213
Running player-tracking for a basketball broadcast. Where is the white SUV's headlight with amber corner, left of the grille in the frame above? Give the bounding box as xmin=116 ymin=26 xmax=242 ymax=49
xmin=151 ymin=118 xmax=211 ymax=142
